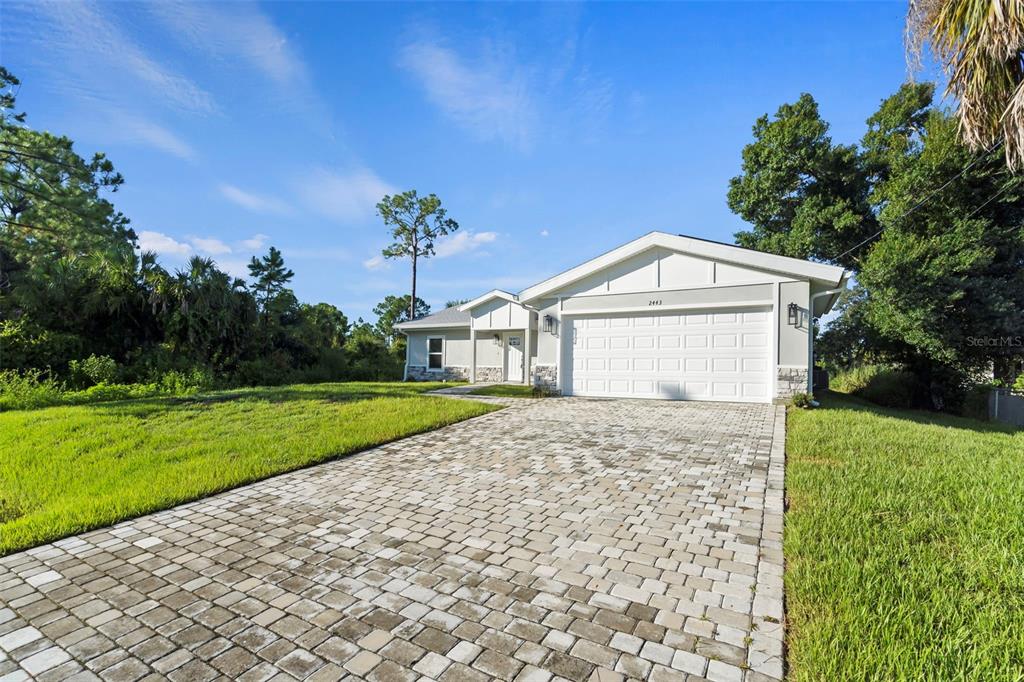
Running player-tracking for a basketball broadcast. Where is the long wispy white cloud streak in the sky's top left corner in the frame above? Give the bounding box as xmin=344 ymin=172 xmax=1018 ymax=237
xmin=14 ymin=0 xmax=218 ymax=115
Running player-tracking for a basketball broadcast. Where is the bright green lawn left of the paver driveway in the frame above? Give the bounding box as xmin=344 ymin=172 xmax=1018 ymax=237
xmin=0 ymin=383 xmax=499 ymax=555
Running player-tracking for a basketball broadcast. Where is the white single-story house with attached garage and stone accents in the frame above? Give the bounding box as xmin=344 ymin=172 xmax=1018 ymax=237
xmin=397 ymin=232 xmax=848 ymax=402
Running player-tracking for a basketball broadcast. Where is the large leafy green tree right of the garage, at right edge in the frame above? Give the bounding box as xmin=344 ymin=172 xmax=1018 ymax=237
xmin=859 ymin=110 xmax=1024 ymax=383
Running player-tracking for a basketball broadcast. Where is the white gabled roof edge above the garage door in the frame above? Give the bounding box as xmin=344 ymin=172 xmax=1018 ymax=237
xmin=518 ymin=231 xmax=845 ymax=302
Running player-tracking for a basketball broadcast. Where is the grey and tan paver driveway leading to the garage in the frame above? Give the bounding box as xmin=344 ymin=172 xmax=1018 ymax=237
xmin=0 ymin=398 xmax=783 ymax=680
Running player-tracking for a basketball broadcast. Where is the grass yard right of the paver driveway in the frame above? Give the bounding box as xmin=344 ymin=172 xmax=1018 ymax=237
xmin=784 ymin=394 xmax=1024 ymax=680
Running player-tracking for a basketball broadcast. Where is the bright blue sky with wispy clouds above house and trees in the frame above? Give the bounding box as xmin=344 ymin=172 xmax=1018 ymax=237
xmin=0 ymin=2 xmax=907 ymax=319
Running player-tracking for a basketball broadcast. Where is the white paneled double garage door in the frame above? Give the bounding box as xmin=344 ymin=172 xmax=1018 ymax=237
xmin=566 ymin=308 xmax=771 ymax=402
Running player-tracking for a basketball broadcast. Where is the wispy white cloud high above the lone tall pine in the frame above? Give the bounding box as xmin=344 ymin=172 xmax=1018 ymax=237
xmin=398 ymin=39 xmax=538 ymax=148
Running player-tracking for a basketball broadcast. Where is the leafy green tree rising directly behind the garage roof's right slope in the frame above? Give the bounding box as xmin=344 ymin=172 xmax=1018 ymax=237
xmin=727 ymin=93 xmax=878 ymax=264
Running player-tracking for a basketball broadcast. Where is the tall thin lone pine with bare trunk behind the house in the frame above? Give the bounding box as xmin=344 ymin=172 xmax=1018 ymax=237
xmin=377 ymin=189 xmax=459 ymax=319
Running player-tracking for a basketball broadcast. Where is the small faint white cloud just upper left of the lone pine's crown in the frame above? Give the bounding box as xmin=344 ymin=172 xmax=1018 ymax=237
xmin=296 ymin=168 xmax=395 ymax=222
